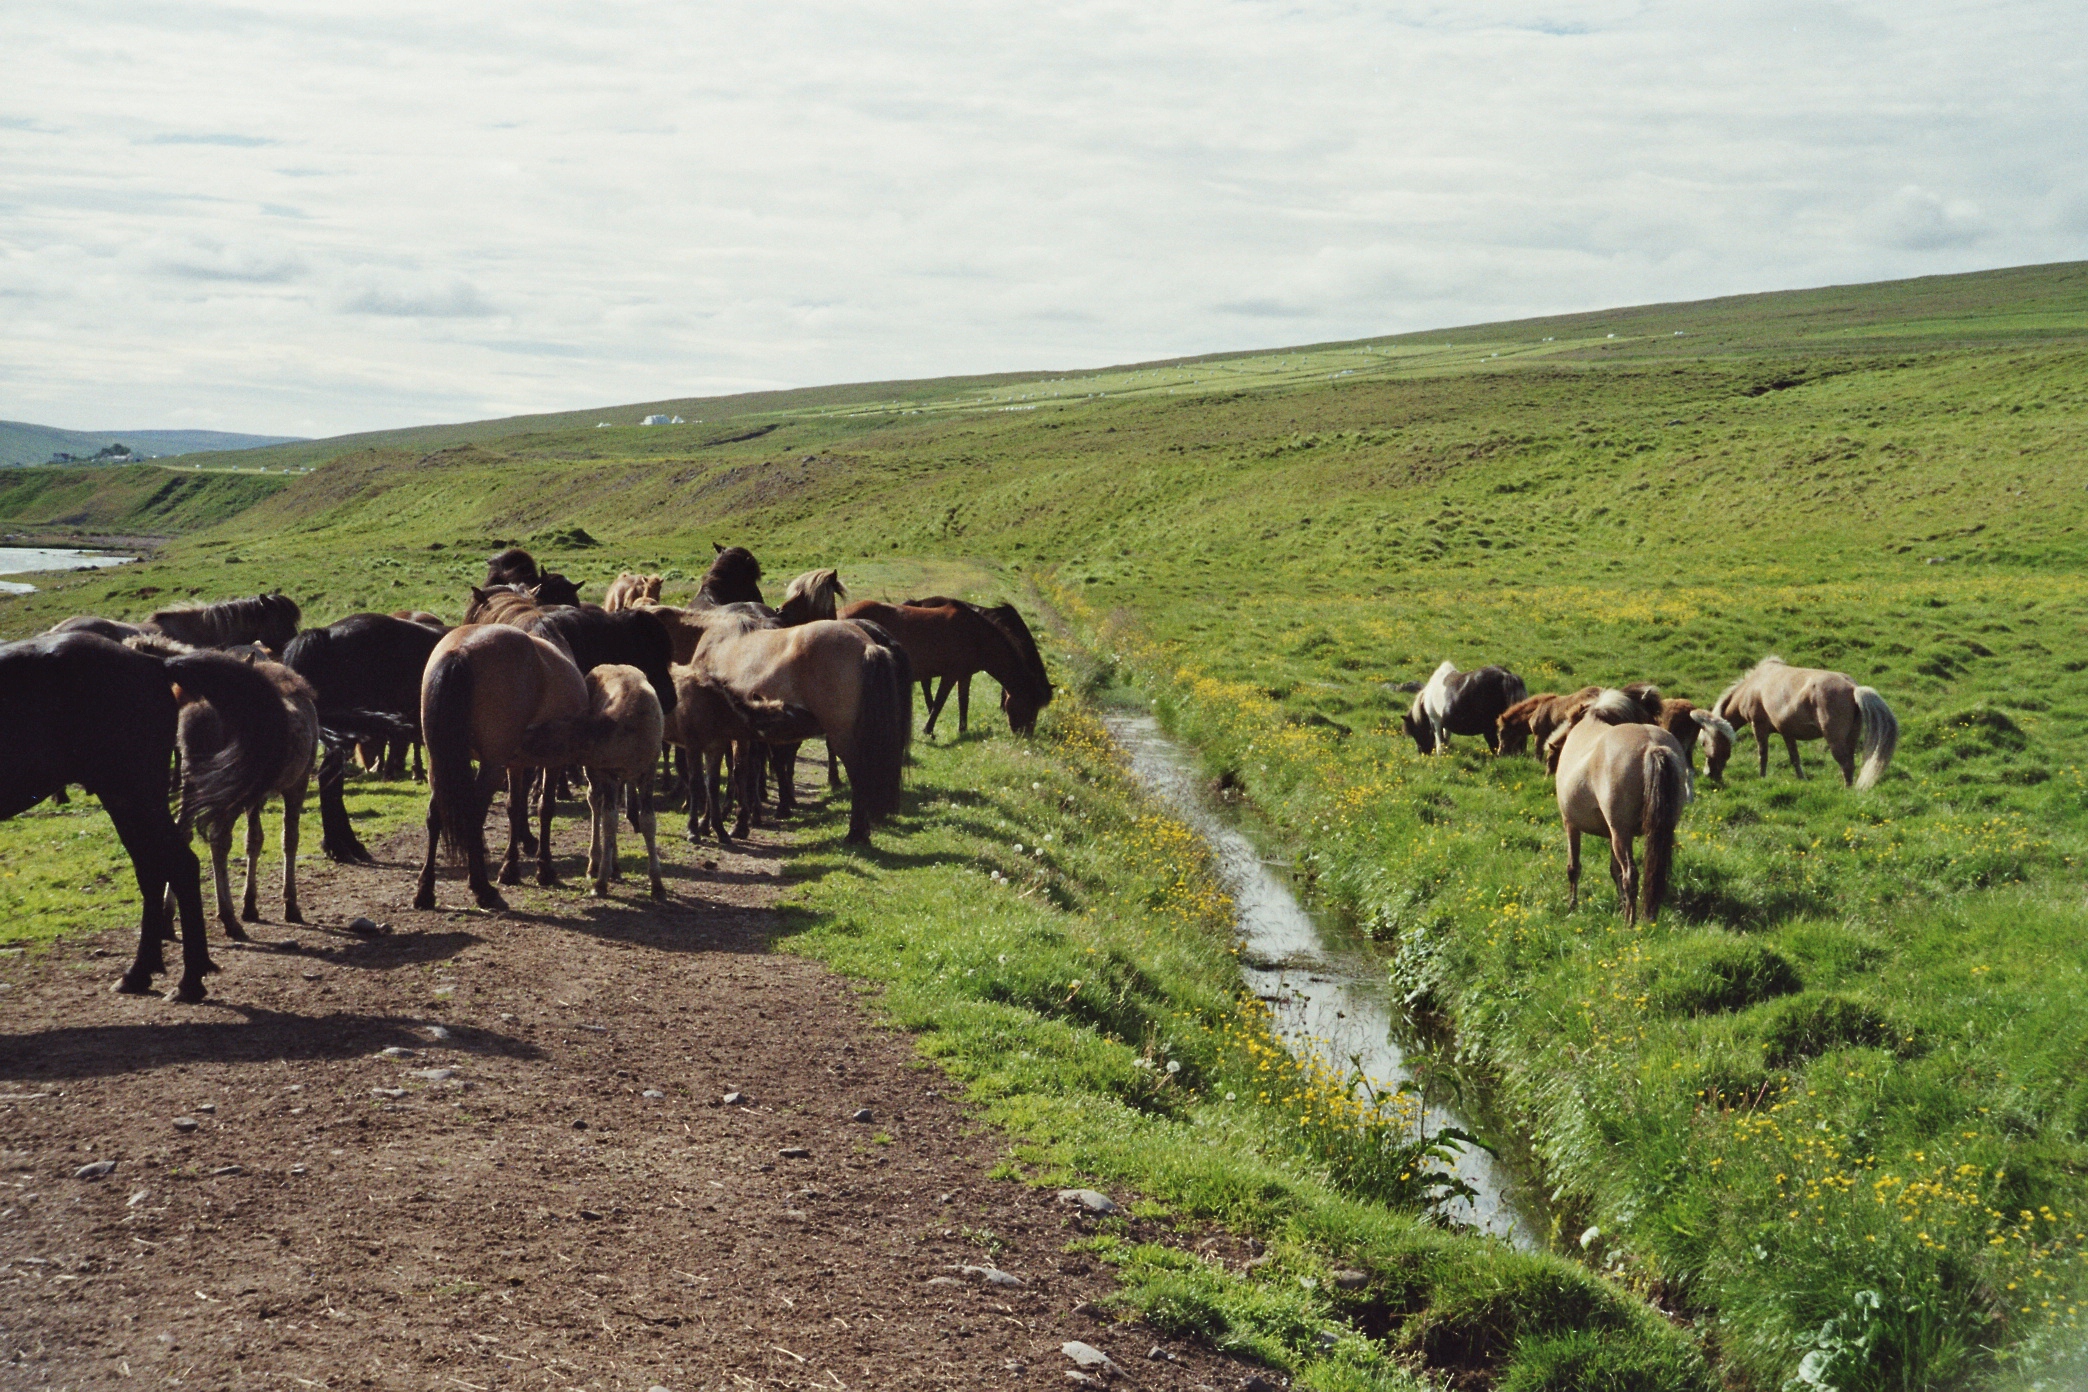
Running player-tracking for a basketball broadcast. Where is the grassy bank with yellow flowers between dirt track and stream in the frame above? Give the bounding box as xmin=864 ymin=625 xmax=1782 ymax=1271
xmin=789 ymin=699 xmax=1708 ymax=1390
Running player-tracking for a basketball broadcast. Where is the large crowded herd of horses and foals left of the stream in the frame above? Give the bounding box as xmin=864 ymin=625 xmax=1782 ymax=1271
xmin=0 ymin=547 xmax=1052 ymax=1002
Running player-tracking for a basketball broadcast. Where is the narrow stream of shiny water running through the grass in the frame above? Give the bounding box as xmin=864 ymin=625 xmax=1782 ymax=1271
xmin=1102 ymin=710 xmax=1539 ymax=1250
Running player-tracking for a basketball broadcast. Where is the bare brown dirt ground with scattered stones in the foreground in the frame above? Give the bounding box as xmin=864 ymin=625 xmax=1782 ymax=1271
xmin=0 ymin=778 xmax=1274 ymax=1392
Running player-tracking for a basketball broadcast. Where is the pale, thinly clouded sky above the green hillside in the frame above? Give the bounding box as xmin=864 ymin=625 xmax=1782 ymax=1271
xmin=0 ymin=0 xmax=2088 ymax=436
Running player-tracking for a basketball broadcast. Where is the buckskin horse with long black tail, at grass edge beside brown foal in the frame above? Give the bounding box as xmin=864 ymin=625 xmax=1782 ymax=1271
xmin=691 ymin=614 xmax=912 ymax=843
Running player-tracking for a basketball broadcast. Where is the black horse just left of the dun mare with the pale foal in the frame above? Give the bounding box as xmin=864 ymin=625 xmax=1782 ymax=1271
xmin=282 ymin=614 xmax=443 ymax=864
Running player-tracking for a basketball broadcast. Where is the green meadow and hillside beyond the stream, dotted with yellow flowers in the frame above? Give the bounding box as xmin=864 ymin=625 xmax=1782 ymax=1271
xmin=0 ymin=265 xmax=2088 ymax=1392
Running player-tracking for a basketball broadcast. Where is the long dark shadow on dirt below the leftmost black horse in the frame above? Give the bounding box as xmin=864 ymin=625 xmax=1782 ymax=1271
xmin=0 ymin=1002 xmax=543 ymax=1079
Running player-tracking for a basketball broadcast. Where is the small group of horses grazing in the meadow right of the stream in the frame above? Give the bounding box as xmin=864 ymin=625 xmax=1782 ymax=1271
xmin=1405 ymin=657 xmax=1900 ymax=925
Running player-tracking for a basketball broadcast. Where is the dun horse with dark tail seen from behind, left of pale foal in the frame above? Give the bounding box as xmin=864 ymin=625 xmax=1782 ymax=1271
xmin=413 ymin=624 xmax=589 ymax=910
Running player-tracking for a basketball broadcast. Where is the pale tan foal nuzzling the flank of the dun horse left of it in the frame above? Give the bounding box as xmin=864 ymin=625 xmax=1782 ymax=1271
xmin=520 ymin=662 xmax=666 ymax=899
